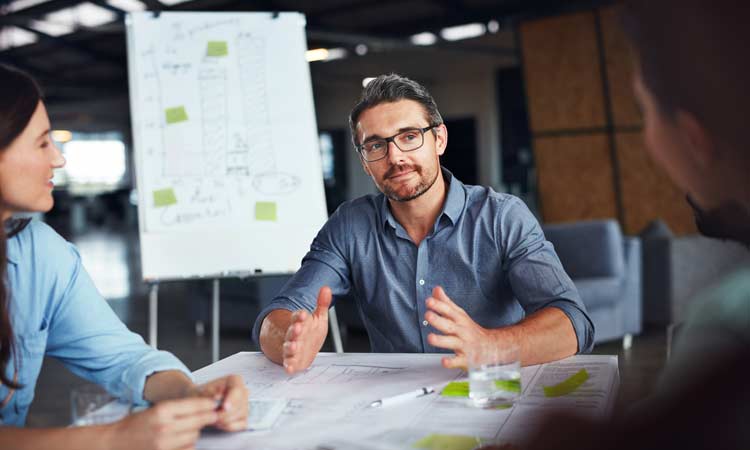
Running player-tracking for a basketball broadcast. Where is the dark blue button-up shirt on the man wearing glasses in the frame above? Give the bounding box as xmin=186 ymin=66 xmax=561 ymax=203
xmin=253 ymin=168 xmax=594 ymax=352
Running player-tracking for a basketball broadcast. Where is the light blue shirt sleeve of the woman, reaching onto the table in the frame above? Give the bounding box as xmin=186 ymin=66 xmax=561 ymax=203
xmin=35 ymin=229 xmax=192 ymax=404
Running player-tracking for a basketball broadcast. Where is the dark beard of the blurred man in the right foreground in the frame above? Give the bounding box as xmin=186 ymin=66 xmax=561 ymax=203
xmin=687 ymin=194 xmax=750 ymax=248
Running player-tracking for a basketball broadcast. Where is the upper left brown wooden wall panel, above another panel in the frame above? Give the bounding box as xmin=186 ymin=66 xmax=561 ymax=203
xmin=520 ymin=12 xmax=606 ymax=132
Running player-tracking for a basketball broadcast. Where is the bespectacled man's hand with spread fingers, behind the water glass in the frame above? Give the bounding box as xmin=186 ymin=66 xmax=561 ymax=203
xmin=424 ymin=286 xmax=494 ymax=369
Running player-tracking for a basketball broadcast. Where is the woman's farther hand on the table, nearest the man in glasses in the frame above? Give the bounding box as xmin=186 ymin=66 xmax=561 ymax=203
xmin=190 ymin=375 xmax=249 ymax=431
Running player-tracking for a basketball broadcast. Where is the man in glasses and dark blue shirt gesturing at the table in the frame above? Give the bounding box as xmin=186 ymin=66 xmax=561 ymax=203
xmin=253 ymin=74 xmax=594 ymax=373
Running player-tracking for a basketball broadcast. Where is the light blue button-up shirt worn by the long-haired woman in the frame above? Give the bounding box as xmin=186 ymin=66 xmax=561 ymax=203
xmin=0 ymin=221 xmax=192 ymax=426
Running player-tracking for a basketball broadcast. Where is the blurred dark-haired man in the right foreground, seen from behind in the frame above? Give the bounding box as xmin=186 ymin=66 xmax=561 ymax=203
xmin=482 ymin=0 xmax=750 ymax=450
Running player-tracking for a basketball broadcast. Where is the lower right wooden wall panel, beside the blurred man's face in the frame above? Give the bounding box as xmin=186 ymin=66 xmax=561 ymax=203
xmin=616 ymin=133 xmax=697 ymax=235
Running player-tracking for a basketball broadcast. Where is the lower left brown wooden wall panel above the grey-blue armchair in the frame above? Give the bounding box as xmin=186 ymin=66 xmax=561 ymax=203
xmin=534 ymin=133 xmax=617 ymax=223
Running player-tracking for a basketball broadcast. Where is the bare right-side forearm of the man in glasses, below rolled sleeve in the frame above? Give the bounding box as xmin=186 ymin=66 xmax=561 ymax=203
xmin=495 ymin=307 xmax=578 ymax=366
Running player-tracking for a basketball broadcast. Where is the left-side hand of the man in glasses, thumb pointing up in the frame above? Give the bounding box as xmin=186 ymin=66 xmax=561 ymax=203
xmin=283 ymin=286 xmax=332 ymax=374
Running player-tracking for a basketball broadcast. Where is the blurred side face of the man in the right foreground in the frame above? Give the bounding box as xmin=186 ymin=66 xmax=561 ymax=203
xmin=634 ymin=71 xmax=750 ymax=245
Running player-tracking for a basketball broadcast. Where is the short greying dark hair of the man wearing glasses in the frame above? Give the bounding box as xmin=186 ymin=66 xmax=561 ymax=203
xmin=349 ymin=73 xmax=443 ymax=146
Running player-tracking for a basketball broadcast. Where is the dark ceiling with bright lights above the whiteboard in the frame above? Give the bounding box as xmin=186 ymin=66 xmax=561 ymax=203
xmin=0 ymin=0 xmax=611 ymax=103
